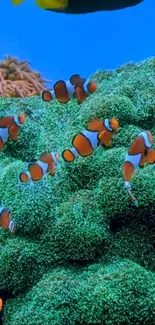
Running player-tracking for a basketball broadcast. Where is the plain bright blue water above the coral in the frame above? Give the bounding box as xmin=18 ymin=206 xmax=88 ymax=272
xmin=0 ymin=0 xmax=155 ymax=81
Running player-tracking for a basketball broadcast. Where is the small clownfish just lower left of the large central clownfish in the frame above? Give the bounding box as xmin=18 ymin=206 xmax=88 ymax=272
xmin=19 ymin=152 xmax=59 ymax=183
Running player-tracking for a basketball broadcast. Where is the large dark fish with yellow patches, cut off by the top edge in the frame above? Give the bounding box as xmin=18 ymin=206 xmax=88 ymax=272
xmin=12 ymin=0 xmax=144 ymax=14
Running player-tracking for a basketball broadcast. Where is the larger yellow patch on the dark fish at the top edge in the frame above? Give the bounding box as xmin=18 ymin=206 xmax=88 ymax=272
xmin=36 ymin=0 xmax=68 ymax=9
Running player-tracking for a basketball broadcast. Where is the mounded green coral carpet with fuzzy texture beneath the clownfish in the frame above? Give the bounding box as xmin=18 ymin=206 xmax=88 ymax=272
xmin=0 ymin=58 xmax=155 ymax=325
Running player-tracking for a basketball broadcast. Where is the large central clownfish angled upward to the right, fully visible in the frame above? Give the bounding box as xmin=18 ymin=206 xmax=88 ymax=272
xmin=62 ymin=118 xmax=119 ymax=162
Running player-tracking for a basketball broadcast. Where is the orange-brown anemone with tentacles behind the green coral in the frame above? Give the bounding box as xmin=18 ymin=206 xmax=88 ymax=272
xmin=0 ymin=56 xmax=48 ymax=98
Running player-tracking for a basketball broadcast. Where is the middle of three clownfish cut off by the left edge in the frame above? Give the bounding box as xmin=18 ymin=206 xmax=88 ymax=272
xmin=0 ymin=207 xmax=15 ymax=232
